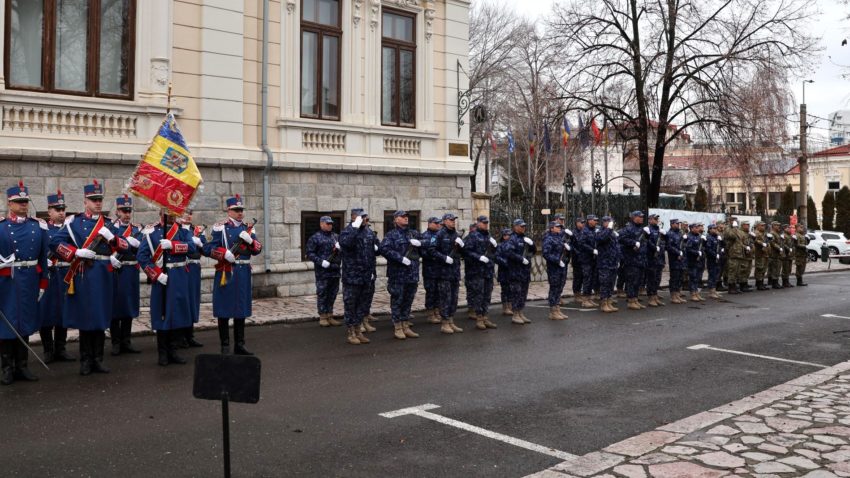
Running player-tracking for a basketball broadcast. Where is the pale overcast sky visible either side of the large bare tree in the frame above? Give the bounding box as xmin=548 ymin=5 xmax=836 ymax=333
xmin=479 ymin=0 xmax=850 ymax=150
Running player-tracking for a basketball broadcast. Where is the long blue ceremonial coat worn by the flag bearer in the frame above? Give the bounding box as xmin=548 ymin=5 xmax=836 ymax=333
xmin=137 ymin=224 xmax=197 ymax=330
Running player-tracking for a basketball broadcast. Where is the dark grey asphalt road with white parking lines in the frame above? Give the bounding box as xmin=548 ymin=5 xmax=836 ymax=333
xmin=0 ymin=273 xmax=850 ymax=478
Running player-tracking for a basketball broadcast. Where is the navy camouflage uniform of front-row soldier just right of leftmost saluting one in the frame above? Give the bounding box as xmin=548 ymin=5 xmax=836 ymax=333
xmin=379 ymin=227 xmax=420 ymax=324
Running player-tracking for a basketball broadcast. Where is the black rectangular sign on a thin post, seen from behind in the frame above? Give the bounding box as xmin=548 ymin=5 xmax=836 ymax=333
xmin=192 ymin=354 xmax=260 ymax=478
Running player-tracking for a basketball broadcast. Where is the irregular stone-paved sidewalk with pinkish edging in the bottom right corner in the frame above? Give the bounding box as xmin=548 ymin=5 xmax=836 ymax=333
xmin=526 ymin=362 xmax=850 ymax=478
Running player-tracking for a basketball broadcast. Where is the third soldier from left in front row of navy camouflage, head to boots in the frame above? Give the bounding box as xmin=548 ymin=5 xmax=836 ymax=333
xmin=429 ymin=213 xmax=464 ymax=334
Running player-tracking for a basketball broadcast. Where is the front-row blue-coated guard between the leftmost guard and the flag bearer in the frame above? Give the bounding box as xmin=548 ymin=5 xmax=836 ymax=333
xmin=50 ymin=181 xmax=129 ymax=375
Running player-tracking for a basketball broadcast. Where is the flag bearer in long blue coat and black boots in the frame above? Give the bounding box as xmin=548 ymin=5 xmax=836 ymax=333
xmin=137 ymin=211 xmax=199 ymax=367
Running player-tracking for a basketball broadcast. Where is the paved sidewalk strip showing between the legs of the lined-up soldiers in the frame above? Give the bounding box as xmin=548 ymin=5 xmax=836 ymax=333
xmin=41 ymin=261 xmax=850 ymax=343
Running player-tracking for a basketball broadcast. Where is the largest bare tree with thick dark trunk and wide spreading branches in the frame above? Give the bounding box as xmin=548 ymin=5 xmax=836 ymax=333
xmin=550 ymin=0 xmax=816 ymax=207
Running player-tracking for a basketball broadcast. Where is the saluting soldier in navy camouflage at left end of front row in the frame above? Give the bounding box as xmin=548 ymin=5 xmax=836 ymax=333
xmin=339 ymin=208 xmax=376 ymax=345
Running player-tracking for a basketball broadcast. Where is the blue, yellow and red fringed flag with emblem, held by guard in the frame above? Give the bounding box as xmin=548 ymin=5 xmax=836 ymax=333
xmin=129 ymin=113 xmax=203 ymax=216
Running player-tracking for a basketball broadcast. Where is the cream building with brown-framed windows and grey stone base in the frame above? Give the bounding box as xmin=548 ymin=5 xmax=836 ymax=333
xmin=0 ymin=0 xmax=473 ymax=295
